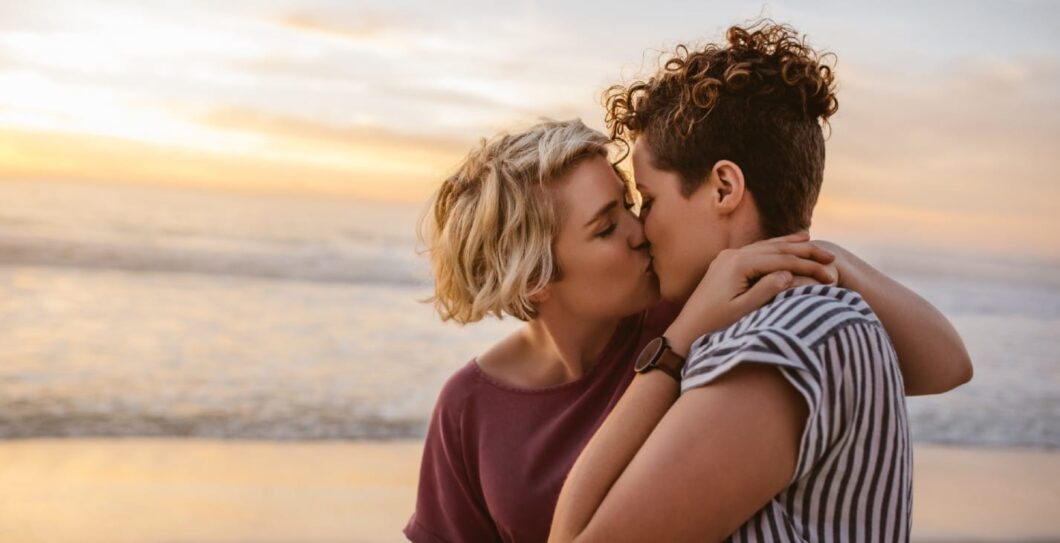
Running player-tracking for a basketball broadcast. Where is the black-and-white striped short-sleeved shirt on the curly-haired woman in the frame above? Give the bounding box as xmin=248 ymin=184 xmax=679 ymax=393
xmin=681 ymin=285 xmax=913 ymax=542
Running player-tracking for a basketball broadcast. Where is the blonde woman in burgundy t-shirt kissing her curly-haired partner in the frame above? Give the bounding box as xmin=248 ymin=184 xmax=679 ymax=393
xmin=404 ymin=120 xmax=968 ymax=543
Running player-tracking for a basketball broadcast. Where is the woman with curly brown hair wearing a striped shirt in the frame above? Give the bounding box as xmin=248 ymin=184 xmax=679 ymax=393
xmin=550 ymin=21 xmax=958 ymax=542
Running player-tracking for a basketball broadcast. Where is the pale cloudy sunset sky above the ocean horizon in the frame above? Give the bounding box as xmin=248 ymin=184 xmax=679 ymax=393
xmin=0 ymin=0 xmax=1060 ymax=258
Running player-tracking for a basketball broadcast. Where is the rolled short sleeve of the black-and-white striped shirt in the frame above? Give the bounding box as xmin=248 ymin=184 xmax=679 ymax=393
xmin=681 ymin=329 xmax=840 ymax=483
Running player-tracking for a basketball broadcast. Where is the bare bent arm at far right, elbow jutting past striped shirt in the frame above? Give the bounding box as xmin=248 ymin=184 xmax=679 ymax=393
xmin=814 ymin=242 xmax=972 ymax=396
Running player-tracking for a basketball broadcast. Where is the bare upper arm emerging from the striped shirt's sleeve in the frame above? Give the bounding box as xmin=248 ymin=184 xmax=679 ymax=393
xmin=549 ymin=364 xmax=807 ymax=543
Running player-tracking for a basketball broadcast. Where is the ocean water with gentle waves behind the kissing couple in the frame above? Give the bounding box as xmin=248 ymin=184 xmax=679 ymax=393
xmin=0 ymin=181 xmax=1060 ymax=449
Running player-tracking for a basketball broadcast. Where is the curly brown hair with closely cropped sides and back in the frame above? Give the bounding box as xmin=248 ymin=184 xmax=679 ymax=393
xmin=605 ymin=19 xmax=838 ymax=237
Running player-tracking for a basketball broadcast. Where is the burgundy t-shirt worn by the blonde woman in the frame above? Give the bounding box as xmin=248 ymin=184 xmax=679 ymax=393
xmin=404 ymin=302 xmax=679 ymax=543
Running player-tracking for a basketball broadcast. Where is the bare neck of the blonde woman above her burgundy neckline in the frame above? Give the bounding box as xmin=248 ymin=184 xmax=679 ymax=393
xmin=523 ymin=304 xmax=621 ymax=384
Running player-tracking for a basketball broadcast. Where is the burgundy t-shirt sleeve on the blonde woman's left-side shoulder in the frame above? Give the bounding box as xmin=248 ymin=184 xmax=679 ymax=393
xmin=403 ymin=382 xmax=500 ymax=543
